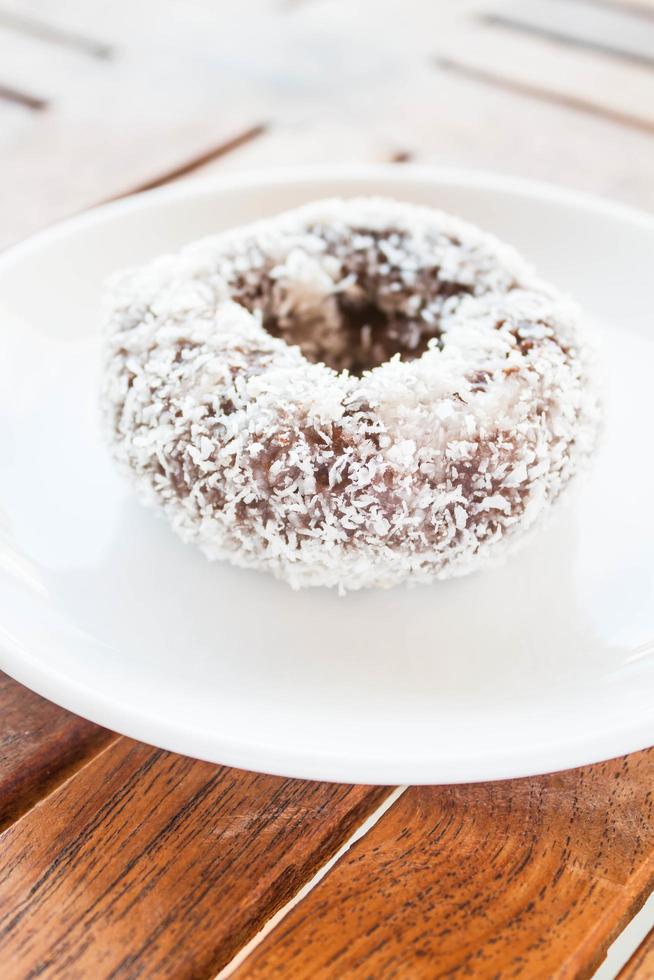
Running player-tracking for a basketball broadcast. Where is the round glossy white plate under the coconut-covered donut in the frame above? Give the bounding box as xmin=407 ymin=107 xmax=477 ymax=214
xmin=0 ymin=167 xmax=654 ymax=783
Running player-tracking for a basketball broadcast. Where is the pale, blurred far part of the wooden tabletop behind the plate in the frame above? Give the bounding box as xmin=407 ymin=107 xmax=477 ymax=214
xmin=0 ymin=0 xmax=654 ymax=245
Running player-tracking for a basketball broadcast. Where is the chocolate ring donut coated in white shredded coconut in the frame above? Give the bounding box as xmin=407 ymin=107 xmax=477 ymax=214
xmin=103 ymin=199 xmax=598 ymax=590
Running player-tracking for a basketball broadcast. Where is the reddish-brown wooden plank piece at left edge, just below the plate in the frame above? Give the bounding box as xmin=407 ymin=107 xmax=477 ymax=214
xmin=0 ymin=673 xmax=115 ymax=830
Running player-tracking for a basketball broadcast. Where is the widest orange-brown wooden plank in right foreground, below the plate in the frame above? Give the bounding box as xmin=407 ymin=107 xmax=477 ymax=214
xmin=233 ymin=750 xmax=654 ymax=980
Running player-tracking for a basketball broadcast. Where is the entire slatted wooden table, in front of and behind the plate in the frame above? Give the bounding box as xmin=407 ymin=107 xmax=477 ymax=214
xmin=0 ymin=0 xmax=654 ymax=980
